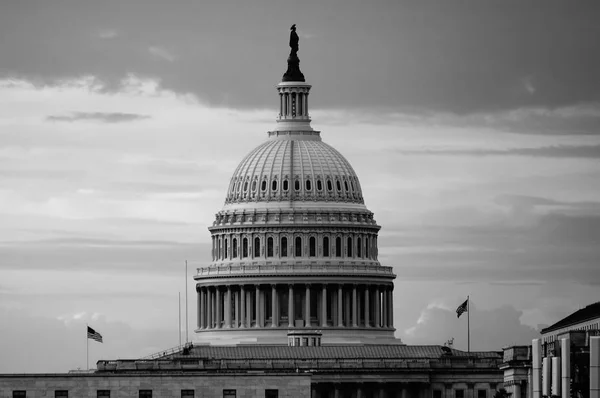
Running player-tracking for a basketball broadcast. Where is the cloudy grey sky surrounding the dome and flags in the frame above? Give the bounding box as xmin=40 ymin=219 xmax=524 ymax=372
xmin=0 ymin=0 xmax=600 ymax=373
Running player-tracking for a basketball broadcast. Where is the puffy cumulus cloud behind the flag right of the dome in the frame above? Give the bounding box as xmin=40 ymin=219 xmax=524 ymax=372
xmin=402 ymin=298 xmax=539 ymax=351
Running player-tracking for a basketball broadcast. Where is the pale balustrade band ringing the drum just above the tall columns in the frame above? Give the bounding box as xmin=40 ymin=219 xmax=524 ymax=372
xmin=197 ymin=262 xmax=394 ymax=276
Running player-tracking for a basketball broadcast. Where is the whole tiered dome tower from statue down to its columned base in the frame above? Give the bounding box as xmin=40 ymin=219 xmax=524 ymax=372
xmin=194 ymin=30 xmax=401 ymax=345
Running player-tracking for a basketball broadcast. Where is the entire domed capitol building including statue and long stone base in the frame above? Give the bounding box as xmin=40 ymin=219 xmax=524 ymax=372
xmin=0 ymin=27 xmax=506 ymax=398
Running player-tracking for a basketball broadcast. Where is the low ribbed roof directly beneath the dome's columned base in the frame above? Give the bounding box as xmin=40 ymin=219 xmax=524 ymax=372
xmin=169 ymin=345 xmax=502 ymax=359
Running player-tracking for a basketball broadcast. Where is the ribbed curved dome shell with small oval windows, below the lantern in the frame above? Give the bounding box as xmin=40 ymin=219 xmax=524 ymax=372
xmin=225 ymin=132 xmax=364 ymax=205
